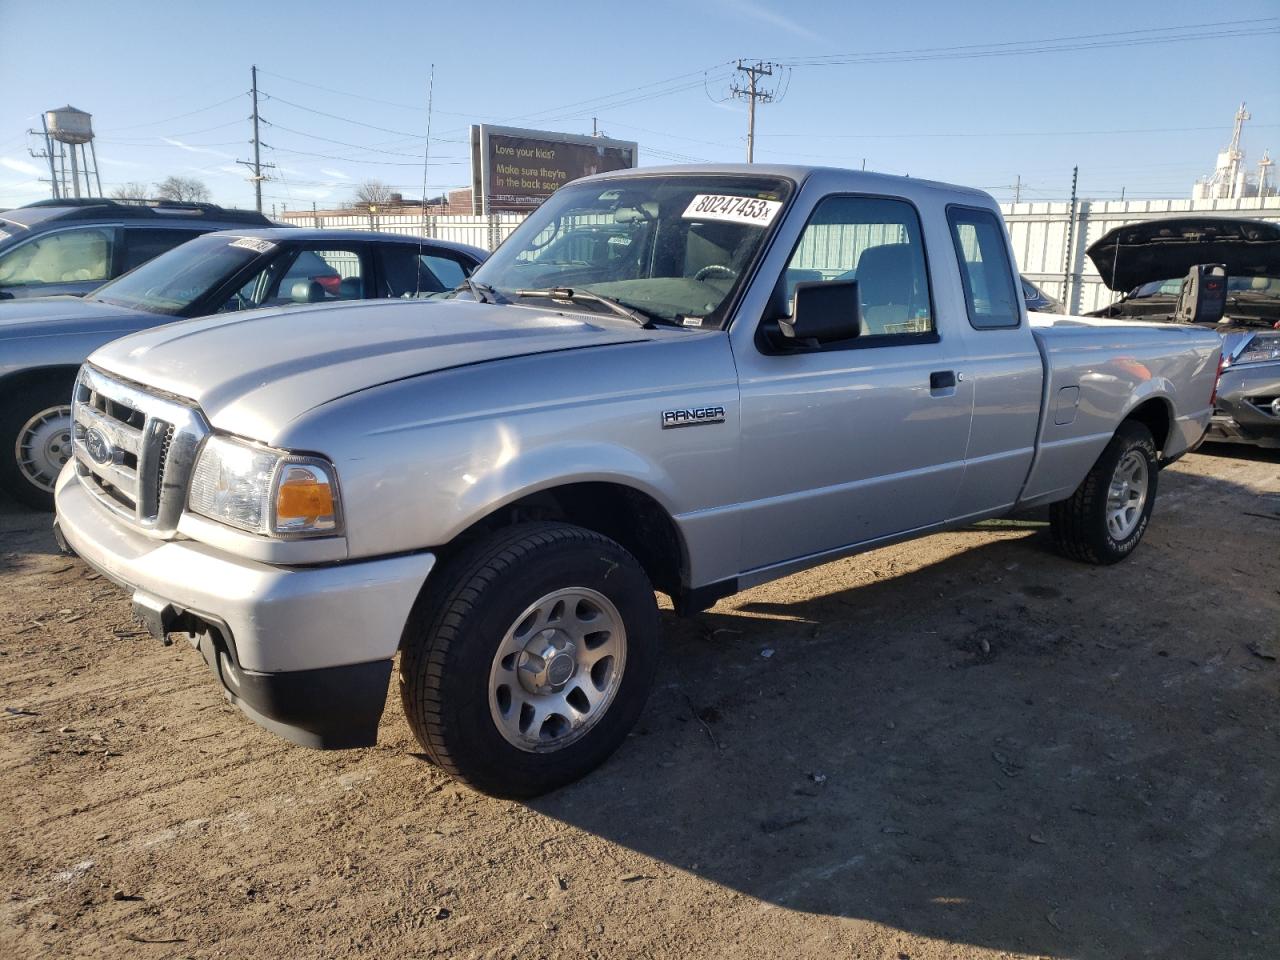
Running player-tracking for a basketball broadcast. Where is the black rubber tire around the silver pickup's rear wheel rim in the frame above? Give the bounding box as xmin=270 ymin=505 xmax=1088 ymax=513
xmin=1050 ymin=420 xmax=1160 ymax=564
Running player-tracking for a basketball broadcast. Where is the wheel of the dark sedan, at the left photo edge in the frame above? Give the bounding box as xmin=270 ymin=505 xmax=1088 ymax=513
xmin=0 ymin=381 xmax=72 ymax=509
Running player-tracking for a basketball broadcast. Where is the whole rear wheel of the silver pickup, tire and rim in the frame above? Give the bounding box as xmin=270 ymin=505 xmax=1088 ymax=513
xmin=1050 ymin=420 xmax=1160 ymax=564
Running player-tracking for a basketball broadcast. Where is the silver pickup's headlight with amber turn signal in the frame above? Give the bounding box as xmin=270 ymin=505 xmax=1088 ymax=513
xmin=187 ymin=436 xmax=342 ymax=539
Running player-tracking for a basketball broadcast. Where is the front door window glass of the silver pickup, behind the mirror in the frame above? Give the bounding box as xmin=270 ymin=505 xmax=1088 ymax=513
xmin=783 ymin=197 xmax=934 ymax=339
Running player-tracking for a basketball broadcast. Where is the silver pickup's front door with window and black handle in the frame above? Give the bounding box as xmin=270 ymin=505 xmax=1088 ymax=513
xmin=736 ymin=196 xmax=973 ymax=572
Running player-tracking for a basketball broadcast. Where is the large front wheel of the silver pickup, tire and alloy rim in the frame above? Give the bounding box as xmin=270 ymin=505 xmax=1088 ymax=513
xmin=399 ymin=522 xmax=659 ymax=797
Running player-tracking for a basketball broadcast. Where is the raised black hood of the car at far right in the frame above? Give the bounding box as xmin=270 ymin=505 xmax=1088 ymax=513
xmin=1085 ymin=216 xmax=1280 ymax=292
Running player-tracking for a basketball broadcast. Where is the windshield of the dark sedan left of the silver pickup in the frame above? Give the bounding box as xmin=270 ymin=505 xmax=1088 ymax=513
xmin=90 ymin=234 xmax=267 ymax=316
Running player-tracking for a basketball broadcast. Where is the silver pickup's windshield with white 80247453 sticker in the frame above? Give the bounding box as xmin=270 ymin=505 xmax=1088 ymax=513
xmin=474 ymin=174 xmax=791 ymax=326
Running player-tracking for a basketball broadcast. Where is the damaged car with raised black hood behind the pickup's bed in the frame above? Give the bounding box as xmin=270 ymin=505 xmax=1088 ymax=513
xmin=1087 ymin=216 xmax=1280 ymax=448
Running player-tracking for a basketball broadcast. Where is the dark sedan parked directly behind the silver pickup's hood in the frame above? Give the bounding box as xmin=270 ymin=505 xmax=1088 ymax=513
xmin=0 ymin=228 xmax=485 ymax=509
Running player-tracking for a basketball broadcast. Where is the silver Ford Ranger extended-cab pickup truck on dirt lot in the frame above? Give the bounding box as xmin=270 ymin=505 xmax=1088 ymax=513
xmin=56 ymin=165 xmax=1220 ymax=796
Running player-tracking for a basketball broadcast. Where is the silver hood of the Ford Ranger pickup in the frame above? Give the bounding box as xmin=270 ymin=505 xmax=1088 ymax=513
xmin=90 ymin=300 xmax=650 ymax=443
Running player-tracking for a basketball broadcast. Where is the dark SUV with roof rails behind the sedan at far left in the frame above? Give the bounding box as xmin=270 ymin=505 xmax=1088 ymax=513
xmin=0 ymin=198 xmax=271 ymax=300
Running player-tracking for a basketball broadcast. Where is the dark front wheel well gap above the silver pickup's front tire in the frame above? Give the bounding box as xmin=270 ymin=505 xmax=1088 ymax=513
xmin=450 ymin=483 xmax=687 ymax=596
